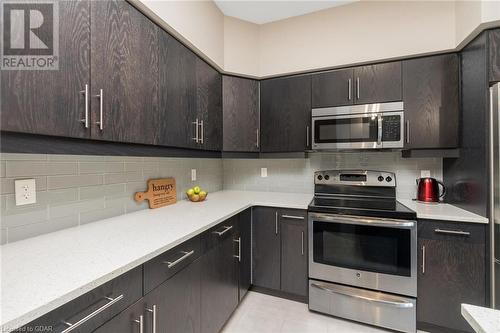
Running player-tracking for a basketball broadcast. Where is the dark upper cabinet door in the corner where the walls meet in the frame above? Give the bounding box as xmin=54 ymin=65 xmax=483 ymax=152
xmin=222 ymin=76 xmax=259 ymax=152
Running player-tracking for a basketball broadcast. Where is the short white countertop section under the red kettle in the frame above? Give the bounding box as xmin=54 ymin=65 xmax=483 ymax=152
xmin=399 ymin=200 xmax=488 ymax=223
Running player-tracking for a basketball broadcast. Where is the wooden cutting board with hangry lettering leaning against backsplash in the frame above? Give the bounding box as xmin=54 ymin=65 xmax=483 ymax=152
xmin=134 ymin=178 xmax=177 ymax=209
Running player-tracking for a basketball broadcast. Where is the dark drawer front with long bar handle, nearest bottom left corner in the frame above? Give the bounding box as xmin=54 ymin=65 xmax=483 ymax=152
xmin=19 ymin=266 xmax=142 ymax=333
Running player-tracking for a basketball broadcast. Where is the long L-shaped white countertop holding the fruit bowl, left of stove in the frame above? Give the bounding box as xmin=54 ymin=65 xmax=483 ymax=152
xmin=0 ymin=191 xmax=312 ymax=332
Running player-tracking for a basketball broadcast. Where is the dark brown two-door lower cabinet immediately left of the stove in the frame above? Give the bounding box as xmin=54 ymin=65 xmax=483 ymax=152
xmin=252 ymin=207 xmax=308 ymax=299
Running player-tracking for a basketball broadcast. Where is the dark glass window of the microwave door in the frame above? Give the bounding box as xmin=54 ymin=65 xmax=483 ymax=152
xmin=314 ymin=116 xmax=378 ymax=143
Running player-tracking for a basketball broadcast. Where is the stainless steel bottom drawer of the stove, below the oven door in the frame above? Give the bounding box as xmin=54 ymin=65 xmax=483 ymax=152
xmin=309 ymin=280 xmax=417 ymax=333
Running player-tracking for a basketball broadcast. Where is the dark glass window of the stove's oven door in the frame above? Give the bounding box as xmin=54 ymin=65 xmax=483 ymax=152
xmin=313 ymin=221 xmax=411 ymax=276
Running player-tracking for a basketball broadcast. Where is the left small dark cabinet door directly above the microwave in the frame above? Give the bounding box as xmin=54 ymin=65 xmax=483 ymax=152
xmin=312 ymin=68 xmax=354 ymax=108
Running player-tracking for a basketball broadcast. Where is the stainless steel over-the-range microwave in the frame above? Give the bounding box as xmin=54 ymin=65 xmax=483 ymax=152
xmin=312 ymin=102 xmax=404 ymax=150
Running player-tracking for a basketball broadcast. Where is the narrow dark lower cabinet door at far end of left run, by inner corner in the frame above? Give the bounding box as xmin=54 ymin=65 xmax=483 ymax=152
xmin=238 ymin=209 xmax=252 ymax=301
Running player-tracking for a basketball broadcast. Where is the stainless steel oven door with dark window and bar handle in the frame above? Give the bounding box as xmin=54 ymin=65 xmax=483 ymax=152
xmin=309 ymin=213 xmax=417 ymax=297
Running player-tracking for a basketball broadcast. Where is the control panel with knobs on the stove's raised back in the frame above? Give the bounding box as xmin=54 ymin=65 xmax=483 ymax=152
xmin=314 ymin=170 xmax=396 ymax=187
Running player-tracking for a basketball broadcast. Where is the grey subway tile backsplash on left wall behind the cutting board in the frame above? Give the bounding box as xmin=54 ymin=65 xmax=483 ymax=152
xmin=0 ymin=153 xmax=222 ymax=244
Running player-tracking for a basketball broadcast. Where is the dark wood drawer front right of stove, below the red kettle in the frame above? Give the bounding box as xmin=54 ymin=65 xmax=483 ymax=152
xmin=417 ymin=219 xmax=487 ymax=244
